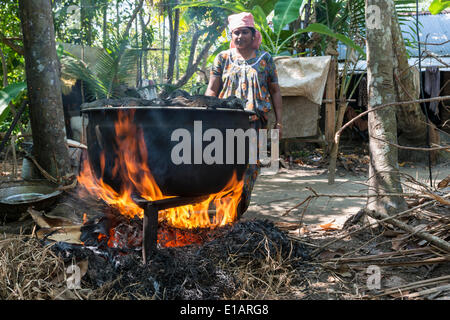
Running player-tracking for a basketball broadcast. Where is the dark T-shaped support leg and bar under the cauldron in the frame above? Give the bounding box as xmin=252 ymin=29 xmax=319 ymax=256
xmin=133 ymin=196 xmax=208 ymax=264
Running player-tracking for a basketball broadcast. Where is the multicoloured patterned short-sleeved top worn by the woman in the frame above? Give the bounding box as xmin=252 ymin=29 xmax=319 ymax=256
xmin=211 ymin=49 xmax=278 ymax=120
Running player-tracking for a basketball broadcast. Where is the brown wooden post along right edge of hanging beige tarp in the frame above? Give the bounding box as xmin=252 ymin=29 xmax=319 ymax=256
xmin=325 ymin=57 xmax=336 ymax=154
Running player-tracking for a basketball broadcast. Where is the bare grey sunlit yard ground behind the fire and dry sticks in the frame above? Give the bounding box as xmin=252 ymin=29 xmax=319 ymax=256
xmin=244 ymin=156 xmax=450 ymax=227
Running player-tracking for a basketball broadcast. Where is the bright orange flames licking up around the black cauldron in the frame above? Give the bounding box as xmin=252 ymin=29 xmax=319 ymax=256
xmin=78 ymin=111 xmax=243 ymax=229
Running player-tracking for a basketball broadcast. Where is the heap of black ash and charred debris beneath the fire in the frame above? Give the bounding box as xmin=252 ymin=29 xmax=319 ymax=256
xmin=53 ymin=220 xmax=309 ymax=300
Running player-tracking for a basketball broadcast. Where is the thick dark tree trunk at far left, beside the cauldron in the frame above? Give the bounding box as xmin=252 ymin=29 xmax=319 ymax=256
xmin=19 ymin=0 xmax=71 ymax=182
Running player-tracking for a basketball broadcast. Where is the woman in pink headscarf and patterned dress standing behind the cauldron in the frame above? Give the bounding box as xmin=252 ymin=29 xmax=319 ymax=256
xmin=205 ymin=12 xmax=282 ymax=217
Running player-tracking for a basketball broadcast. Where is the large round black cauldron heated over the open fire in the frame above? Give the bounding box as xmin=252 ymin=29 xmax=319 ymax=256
xmin=82 ymin=106 xmax=253 ymax=197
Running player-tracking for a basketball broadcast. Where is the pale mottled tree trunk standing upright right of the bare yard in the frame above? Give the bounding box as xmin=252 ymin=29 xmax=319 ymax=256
xmin=366 ymin=0 xmax=406 ymax=214
